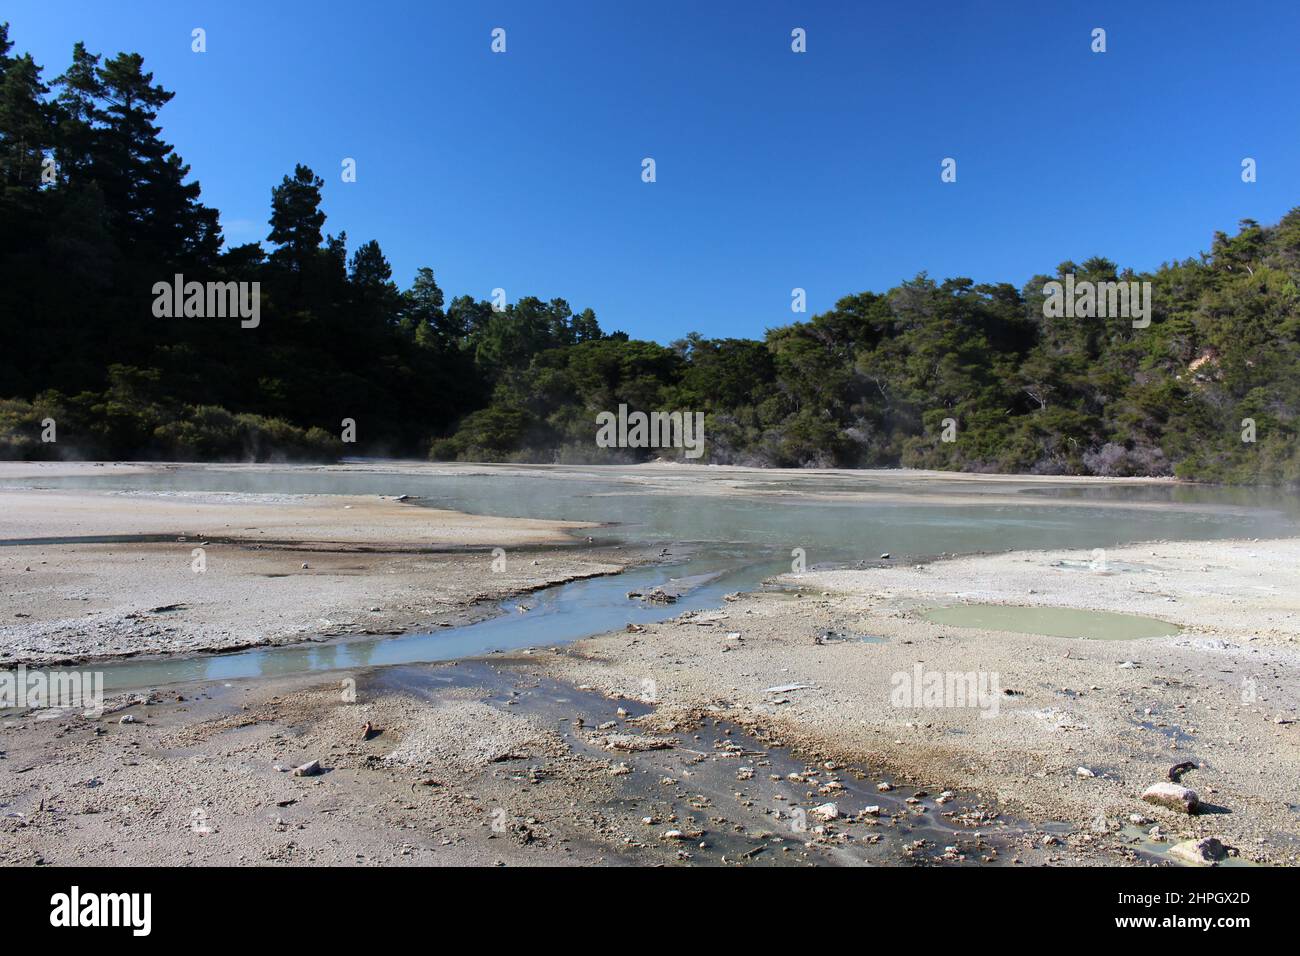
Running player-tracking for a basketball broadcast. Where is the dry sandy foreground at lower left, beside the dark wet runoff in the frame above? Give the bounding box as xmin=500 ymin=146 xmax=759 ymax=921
xmin=0 ymin=675 xmax=618 ymax=865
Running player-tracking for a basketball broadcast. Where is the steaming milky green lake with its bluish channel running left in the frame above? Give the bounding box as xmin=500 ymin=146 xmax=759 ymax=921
xmin=0 ymin=463 xmax=1297 ymax=689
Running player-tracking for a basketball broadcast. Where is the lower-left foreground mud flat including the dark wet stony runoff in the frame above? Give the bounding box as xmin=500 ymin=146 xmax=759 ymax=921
xmin=0 ymin=652 xmax=1047 ymax=866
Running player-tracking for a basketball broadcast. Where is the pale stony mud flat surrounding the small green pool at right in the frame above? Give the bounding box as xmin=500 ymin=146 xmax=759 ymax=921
xmin=550 ymin=540 xmax=1300 ymax=865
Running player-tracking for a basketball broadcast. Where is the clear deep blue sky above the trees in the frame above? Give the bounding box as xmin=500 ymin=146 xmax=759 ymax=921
xmin=10 ymin=0 xmax=1300 ymax=342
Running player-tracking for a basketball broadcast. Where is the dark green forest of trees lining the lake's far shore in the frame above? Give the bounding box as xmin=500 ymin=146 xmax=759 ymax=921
xmin=0 ymin=26 xmax=1300 ymax=485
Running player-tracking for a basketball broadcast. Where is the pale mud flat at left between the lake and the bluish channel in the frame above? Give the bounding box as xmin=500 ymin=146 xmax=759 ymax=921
xmin=0 ymin=486 xmax=624 ymax=666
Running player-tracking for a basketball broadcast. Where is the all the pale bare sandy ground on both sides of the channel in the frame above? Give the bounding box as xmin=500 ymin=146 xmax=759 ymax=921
xmin=0 ymin=464 xmax=1300 ymax=865
